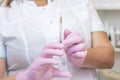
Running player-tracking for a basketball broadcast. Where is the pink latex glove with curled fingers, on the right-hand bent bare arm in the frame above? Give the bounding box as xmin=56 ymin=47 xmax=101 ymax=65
xmin=62 ymin=29 xmax=87 ymax=67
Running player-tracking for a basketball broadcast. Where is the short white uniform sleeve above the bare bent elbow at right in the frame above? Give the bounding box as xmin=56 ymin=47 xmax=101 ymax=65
xmin=87 ymin=0 xmax=106 ymax=32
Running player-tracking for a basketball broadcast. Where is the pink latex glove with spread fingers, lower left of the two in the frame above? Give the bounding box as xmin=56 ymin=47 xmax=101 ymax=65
xmin=16 ymin=43 xmax=71 ymax=80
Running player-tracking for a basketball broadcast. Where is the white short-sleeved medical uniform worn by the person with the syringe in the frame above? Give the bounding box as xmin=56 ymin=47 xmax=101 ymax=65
xmin=0 ymin=0 xmax=105 ymax=80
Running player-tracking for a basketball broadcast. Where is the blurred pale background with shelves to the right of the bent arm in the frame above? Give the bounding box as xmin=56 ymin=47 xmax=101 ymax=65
xmin=93 ymin=0 xmax=120 ymax=80
